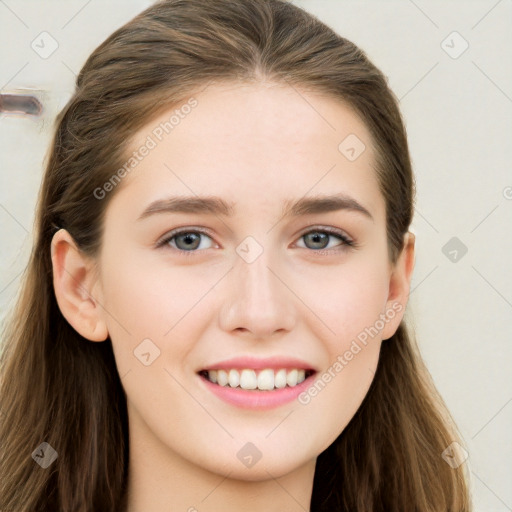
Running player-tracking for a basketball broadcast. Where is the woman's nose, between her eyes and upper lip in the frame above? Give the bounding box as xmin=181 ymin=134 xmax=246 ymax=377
xmin=219 ymin=251 xmax=297 ymax=339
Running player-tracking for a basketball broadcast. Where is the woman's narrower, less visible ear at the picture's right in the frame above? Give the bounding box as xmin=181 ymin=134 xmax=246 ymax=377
xmin=382 ymin=231 xmax=416 ymax=340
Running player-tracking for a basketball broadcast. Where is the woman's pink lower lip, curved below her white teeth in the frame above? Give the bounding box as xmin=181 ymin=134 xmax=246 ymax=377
xmin=199 ymin=373 xmax=315 ymax=410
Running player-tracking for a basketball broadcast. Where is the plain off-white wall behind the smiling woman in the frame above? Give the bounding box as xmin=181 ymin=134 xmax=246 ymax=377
xmin=0 ymin=0 xmax=512 ymax=512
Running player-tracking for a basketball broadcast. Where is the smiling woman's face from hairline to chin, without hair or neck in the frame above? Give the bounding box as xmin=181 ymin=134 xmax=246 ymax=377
xmin=92 ymin=83 xmax=405 ymax=480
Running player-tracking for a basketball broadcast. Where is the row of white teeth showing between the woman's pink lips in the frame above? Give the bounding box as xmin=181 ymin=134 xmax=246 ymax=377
xmin=199 ymin=368 xmax=315 ymax=391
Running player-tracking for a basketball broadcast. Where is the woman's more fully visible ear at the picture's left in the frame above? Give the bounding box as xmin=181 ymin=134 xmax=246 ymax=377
xmin=51 ymin=229 xmax=108 ymax=341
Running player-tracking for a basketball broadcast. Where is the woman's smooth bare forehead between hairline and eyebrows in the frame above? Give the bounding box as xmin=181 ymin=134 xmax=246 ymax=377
xmin=108 ymin=83 xmax=382 ymax=220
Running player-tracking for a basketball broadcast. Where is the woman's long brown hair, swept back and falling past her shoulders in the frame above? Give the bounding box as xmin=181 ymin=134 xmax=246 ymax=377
xmin=0 ymin=0 xmax=470 ymax=512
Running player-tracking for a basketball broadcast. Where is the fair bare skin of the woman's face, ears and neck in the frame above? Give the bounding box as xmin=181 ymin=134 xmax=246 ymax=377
xmin=52 ymin=83 xmax=414 ymax=512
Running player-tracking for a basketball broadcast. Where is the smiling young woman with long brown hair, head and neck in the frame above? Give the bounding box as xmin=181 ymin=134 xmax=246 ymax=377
xmin=0 ymin=0 xmax=470 ymax=512
